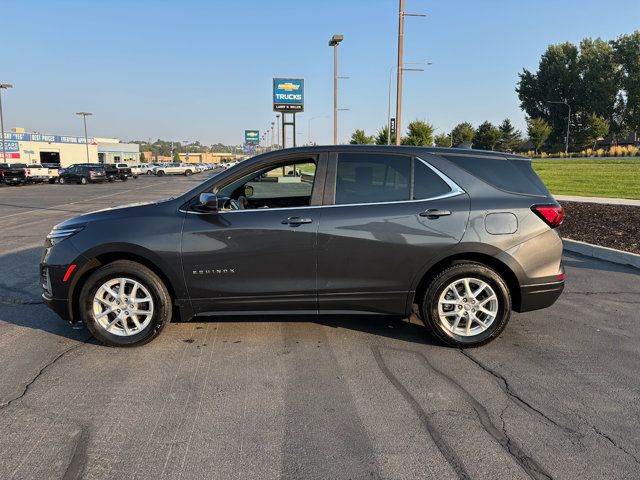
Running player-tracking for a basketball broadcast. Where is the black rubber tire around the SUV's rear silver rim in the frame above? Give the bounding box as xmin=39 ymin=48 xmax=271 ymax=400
xmin=420 ymin=262 xmax=511 ymax=348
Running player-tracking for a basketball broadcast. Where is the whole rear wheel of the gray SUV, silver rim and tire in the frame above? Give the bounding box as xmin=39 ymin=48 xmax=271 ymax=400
xmin=421 ymin=262 xmax=511 ymax=348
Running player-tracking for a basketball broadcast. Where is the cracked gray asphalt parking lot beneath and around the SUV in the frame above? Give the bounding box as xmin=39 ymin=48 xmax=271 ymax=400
xmin=0 ymin=174 xmax=640 ymax=479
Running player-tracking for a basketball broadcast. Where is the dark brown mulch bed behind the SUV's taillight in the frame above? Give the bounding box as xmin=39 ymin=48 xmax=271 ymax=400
xmin=560 ymin=202 xmax=640 ymax=254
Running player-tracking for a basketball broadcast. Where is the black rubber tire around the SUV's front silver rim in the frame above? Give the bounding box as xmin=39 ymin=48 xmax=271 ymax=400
xmin=79 ymin=260 xmax=172 ymax=347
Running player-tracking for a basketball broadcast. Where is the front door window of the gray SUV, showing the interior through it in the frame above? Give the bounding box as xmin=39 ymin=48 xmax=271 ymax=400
xmin=220 ymin=160 xmax=316 ymax=210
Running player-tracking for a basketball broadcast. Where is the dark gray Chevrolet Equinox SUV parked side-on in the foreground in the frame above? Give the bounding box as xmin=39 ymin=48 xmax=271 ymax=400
xmin=40 ymin=146 xmax=564 ymax=347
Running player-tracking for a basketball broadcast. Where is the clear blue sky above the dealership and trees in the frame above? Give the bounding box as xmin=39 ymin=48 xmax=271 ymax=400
xmin=0 ymin=0 xmax=640 ymax=144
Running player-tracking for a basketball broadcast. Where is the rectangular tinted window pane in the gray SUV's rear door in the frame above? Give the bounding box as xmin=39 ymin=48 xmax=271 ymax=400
xmin=336 ymin=153 xmax=411 ymax=205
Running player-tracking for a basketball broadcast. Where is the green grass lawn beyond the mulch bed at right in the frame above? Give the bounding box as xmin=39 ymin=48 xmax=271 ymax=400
xmin=532 ymin=158 xmax=640 ymax=199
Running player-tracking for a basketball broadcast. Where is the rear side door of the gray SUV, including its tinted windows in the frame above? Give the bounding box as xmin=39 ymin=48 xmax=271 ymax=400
xmin=318 ymin=152 xmax=469 ymax=314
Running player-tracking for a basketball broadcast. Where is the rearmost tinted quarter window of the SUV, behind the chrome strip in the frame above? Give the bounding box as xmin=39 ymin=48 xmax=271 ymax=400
xmin=451 ymin=156 xmax=549 ymax=196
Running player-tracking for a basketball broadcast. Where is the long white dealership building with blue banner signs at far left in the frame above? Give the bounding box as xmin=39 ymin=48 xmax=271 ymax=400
xmin=0 ymin=128 xmax=140 ymax=167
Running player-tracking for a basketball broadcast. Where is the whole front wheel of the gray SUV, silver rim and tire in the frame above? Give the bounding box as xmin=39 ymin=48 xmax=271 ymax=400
xmin=80 ymin=260 xmax=171 ymax=347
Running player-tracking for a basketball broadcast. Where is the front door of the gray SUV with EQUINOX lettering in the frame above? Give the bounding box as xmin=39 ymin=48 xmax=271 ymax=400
xmin=182 ymin=158 xmax=324 ymax=313
